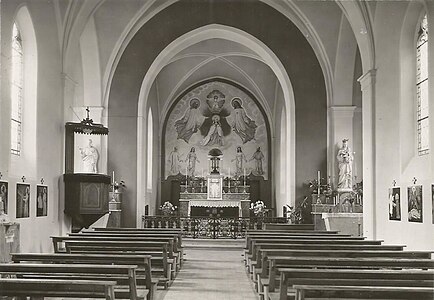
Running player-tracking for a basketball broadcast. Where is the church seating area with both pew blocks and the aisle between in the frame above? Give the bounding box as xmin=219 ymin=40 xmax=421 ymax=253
xmin=0 ymin=223 xmax=434 ymax=300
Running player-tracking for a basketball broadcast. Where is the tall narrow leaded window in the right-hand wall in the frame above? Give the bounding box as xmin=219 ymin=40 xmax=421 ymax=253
xmin=416 ymin=14 xmax=429 ymax=155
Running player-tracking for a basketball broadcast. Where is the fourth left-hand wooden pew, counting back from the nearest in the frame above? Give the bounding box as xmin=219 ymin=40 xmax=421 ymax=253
xmin=64 ymin=240 xmax=174 ymax=287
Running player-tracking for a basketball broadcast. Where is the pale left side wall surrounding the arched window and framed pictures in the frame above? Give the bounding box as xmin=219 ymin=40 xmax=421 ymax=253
xmin=0 ymin=0 xmax=64 ymax=252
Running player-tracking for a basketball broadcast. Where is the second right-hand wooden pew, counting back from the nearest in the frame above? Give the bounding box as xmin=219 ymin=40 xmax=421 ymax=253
xmin=278 ymin=268 xmax=434 ymax=300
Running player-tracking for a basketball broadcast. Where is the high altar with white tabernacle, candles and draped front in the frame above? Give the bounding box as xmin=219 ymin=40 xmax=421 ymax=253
xmin=179 ymin=151 xmax=250 ymax=217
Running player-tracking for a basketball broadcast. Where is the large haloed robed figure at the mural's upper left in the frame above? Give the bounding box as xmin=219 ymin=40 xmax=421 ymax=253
xmin=175 ymin=98 xmax=203 ymax=143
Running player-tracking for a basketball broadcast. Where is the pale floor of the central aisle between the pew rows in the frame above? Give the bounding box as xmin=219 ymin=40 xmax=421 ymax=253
xmin=156 ymin=240 xmax=258 ymax=300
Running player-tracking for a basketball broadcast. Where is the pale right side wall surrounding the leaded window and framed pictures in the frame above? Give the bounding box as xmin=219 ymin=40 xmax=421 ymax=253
xmin=374 ymin=2 xmax=434 ymax=249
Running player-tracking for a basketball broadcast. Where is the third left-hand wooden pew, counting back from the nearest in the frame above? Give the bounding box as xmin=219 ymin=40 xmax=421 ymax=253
xmin=11 ymin=253 xmax=158 ymax=300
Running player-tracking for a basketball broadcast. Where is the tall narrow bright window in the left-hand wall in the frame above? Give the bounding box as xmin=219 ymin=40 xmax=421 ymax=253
xmin=11 ymin=23 xmax=24 ymax=156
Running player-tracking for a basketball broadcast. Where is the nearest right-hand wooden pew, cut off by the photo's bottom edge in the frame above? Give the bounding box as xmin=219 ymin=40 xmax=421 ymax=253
xmin=294 ymin=285 xmax=434 ymax=300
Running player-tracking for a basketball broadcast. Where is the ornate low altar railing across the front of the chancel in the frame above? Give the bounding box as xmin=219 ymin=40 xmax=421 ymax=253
xmin=142 ymin=216 xmax=288 ymax=239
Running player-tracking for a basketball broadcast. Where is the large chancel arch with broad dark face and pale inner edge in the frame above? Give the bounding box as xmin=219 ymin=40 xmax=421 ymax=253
xmin=108 ymin=1 xmax=327 ymax=225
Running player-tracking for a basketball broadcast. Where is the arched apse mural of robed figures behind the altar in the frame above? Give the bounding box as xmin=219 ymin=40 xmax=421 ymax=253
xmin=165 ymin=81 xmax=268 ymax=179
